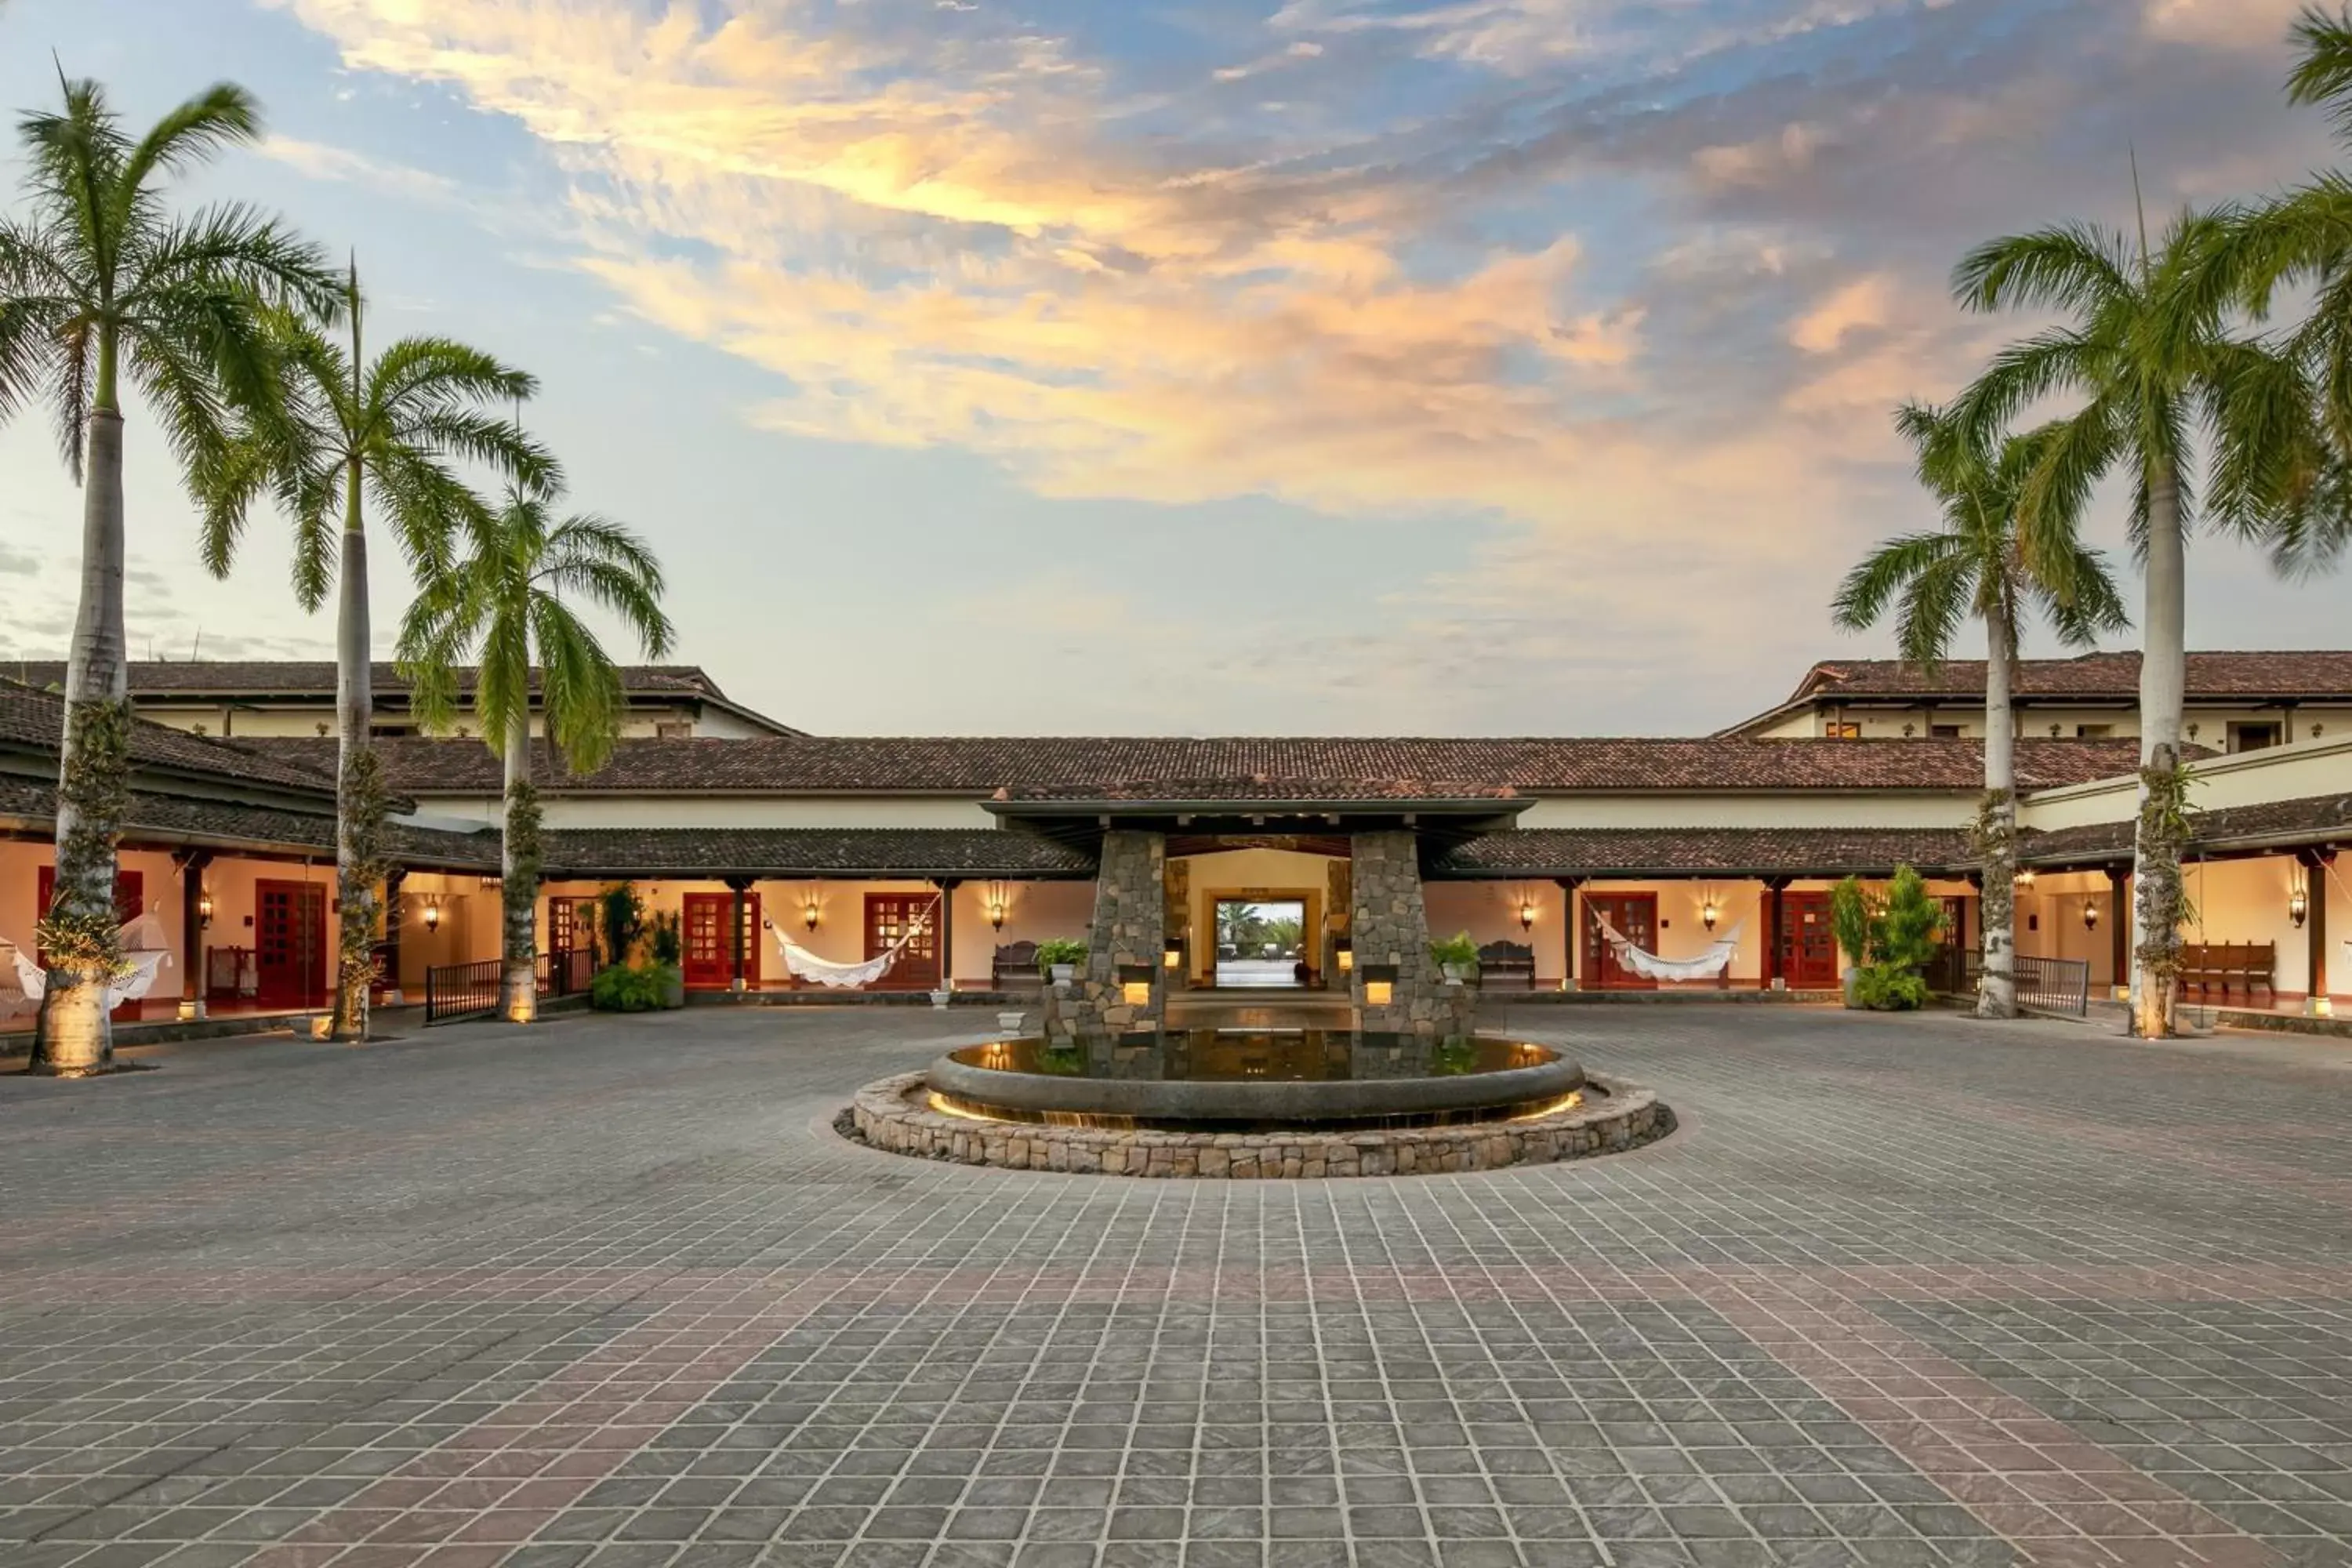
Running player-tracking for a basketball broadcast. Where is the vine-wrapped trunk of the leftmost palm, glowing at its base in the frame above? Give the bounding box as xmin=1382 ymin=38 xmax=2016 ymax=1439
xmin=33 ymin=399 xmax=129 ymax=1076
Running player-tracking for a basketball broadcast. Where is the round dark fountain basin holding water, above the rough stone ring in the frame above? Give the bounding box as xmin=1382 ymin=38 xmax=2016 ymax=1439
xmin=924 ymin=1027 xmax=1588 ymax=1133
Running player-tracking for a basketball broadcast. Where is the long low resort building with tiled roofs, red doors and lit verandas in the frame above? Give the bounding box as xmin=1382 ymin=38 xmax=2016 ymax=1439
xmin=0 ymin=654 xmax=2352 ymax=1022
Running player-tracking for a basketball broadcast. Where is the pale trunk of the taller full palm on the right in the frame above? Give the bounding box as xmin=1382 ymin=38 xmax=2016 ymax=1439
xmin=2117 ymin=461 xmax=2187 ymax=1039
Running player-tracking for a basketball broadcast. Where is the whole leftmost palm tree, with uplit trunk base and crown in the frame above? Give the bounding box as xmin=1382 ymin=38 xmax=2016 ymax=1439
xmin=0 ymin=80 xmax=336 ymax=1076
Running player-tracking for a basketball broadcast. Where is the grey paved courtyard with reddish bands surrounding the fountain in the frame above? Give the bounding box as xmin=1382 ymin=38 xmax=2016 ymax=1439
xmin=0 ymin=1006 xmax=2352 ymax=1568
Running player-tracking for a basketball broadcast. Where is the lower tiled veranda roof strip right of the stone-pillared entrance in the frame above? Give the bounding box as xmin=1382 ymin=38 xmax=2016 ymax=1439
xmin=1432 ymin=827 xmax=1971 ymax=877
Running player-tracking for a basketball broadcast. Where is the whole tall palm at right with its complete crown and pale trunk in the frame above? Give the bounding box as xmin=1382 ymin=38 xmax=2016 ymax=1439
xmin=1952 ymin=212 xmax=2310 ymax=1036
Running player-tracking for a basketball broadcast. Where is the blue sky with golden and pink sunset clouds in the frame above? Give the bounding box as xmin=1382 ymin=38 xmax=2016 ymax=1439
xmin=0 ymin=0 xmax=2345 ymax=734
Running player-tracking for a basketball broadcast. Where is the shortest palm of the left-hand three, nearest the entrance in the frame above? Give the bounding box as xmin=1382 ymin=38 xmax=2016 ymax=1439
xmin=400 ymin=485 xmax=675 ymax=1022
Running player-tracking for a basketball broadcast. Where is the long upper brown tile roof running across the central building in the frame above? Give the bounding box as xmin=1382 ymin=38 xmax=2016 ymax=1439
xmin=240 ymin=736 xmax=2138 ymax=801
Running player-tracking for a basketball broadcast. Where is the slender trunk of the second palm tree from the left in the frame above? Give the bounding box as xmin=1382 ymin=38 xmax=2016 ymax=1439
xmin=332 ymin=459 xmax=383 ymax=1041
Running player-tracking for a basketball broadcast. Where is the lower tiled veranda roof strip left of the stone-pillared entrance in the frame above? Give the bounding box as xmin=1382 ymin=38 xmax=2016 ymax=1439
xmin=543 ymin=827 xmax=1094 ymax=877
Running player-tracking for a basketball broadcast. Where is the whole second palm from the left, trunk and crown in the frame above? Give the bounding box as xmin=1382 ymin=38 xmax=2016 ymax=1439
xmin=205 ymin=268 xmax=553 ymax=1039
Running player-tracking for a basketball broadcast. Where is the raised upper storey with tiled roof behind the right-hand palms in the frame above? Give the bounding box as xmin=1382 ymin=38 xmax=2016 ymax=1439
xmin=1722 ymin=654 xmax=2352 ymax=753
